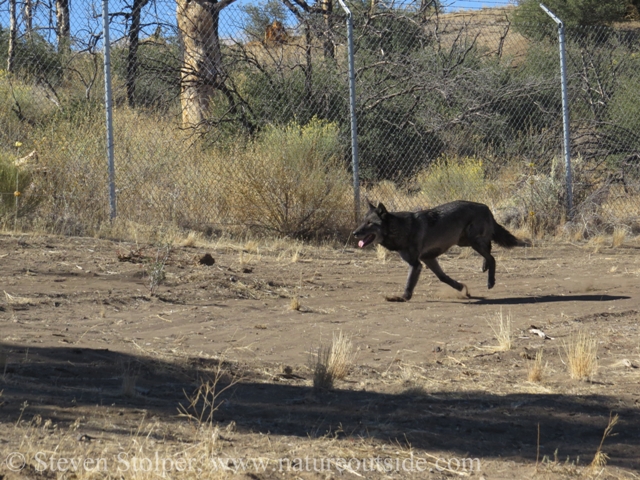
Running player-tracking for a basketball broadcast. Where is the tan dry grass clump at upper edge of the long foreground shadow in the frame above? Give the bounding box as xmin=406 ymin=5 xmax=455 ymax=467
xmin=312 ymin=332 xmax=355 ymax=390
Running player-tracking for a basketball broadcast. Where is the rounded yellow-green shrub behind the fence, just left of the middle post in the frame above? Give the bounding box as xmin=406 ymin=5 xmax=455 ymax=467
xmin=217 ymin=119 xmax=352 ymax=237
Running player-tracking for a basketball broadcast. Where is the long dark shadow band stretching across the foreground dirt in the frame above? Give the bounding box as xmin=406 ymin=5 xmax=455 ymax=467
xmin=0 ymin=343 xmax=640 ymax=469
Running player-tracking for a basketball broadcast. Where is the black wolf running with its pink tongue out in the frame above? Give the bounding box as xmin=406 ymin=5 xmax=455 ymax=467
xmin=353 ymin=200 xmax=525 ymax=302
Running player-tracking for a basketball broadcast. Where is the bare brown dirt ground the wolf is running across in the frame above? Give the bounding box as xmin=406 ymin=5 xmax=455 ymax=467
xmin=0 ymin=234 xmax=640 ymax=480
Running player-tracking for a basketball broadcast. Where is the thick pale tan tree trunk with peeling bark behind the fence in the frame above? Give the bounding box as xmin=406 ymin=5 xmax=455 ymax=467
xmin=176 ymin=0 xmax=235 ymax=127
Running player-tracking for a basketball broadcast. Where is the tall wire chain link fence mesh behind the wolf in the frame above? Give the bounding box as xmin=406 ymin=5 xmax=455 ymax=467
xmin=0 ymin=0 xmax=640 ymax=237
